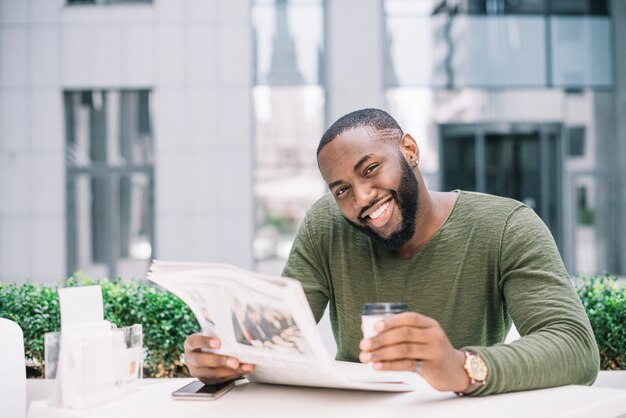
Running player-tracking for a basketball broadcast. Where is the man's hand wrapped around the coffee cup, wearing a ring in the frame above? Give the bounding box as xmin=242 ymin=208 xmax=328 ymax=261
xmin=359 ymin=312 xmax=470 ymax=392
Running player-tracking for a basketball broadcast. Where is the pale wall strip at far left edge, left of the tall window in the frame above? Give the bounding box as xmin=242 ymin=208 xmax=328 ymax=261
xmin=0 ymin=0 xmax=65 ymax=281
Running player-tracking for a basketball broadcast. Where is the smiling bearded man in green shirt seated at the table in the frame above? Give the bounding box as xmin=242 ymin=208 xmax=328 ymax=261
xmin=185 ymin=109 xmax=599 ymax=395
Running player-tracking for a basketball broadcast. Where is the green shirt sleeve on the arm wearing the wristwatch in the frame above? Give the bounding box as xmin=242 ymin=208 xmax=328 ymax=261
xmin=464 ymin=206 xmax=600 ymax=396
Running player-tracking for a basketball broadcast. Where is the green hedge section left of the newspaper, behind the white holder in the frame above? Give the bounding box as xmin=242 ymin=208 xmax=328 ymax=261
xmin=0 ymin=278 xmax=200 ymax=377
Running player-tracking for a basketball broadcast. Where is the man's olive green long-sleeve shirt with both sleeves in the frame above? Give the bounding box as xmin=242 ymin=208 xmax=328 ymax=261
xmin=283 ymin=191 xmax=599 ymax=395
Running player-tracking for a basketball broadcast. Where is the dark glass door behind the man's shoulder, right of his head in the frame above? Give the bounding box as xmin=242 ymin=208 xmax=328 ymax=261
xmin=440 ymin=124 xmax=562 ymax=250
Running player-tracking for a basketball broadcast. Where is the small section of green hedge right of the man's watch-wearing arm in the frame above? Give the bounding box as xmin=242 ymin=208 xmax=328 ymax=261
xmin=575 ymin=273 xmax=626 ymax=370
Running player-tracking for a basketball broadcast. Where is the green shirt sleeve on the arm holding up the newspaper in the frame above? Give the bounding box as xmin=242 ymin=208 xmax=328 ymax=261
xmin=282 ymin=216 xmax=330 ymax=322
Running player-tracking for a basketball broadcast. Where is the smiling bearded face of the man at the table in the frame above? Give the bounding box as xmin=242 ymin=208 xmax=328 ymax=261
xmin=318 ymin=127 xmax=418 ymax=250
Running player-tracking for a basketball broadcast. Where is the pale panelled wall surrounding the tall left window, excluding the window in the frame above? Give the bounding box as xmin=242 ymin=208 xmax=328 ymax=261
xmin=0 ymin=0 xmax=254 ymax=282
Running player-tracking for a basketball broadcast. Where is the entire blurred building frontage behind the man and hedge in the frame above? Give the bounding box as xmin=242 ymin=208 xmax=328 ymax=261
xmin=0 ymin=0 xmax=626 ymax=282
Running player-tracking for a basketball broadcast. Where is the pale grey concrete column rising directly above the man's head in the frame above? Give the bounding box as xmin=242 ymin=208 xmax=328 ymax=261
xmin=325 ymin=0 xmax=386 ymax=125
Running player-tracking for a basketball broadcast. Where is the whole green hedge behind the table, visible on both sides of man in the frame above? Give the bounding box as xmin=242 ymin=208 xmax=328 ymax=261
xmin=0 ymin=274 xmax=626 ymax=377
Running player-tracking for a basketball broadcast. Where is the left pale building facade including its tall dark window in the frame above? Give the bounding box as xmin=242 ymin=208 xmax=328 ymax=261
xmin=0 ymin=0 xmax=254 ymax=282
